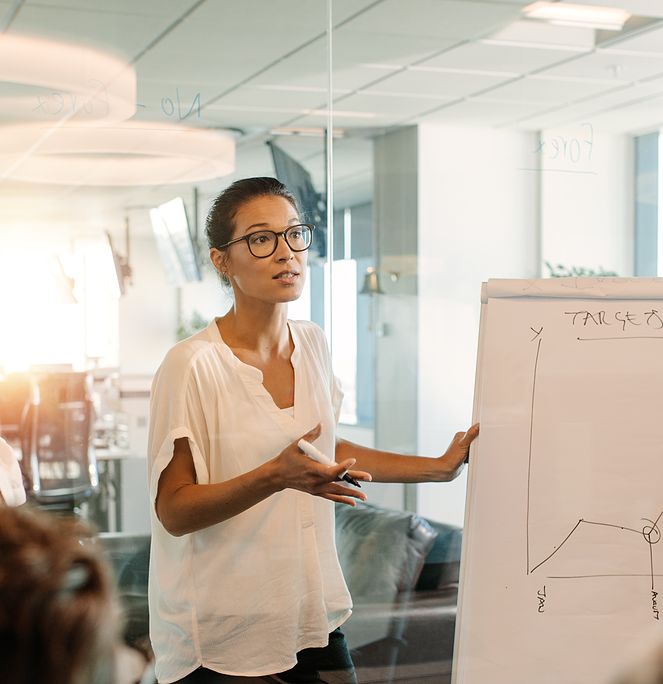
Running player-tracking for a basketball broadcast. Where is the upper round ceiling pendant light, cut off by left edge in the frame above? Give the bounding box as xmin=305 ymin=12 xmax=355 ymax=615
xmin=0 ymin=33 xmax=136 ymax=122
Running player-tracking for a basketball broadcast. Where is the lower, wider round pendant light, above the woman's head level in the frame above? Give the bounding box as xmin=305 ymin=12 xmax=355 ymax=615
xmin=0 ymin=121 xmax=235 ymax=186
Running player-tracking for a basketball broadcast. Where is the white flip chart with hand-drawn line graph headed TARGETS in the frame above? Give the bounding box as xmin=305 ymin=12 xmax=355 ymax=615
xmin=453 ymin=278 xmax=663 ymax=684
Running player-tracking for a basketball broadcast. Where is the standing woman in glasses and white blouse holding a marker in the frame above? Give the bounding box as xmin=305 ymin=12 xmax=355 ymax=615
xmin=148 ymin=178 xmax=478 ymax=684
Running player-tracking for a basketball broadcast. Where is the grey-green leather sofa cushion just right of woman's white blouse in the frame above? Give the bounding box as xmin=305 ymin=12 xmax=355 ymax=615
xmin=336 ymin=503 xmax=437 ymax=604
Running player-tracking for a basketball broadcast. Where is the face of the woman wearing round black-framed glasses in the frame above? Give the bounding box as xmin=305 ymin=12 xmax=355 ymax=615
xmin=212 ymin=195 xmax=308 ymax=304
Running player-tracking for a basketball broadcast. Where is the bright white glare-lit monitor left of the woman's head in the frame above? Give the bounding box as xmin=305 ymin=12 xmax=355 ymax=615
xmin=150 ymin=197 xmax=202 ymax=287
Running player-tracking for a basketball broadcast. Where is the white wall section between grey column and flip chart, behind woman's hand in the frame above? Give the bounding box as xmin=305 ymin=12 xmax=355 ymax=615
xmin=418 ymin=124 xmax=539 ymax=525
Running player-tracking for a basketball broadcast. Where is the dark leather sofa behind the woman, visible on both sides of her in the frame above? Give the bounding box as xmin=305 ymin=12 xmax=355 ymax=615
xmin=99 ymin=504 xmax=462 ymax=684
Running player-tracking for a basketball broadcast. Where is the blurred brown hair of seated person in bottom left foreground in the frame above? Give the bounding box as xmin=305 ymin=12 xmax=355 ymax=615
xmin=0 ymin=507 xmax=119 ymax=684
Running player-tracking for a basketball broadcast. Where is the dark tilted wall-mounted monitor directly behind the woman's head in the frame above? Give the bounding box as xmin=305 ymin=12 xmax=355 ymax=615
xmin=267 ymin=141 xmax=327 ymax=259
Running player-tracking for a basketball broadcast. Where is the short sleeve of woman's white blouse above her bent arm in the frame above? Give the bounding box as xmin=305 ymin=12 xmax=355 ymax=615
xmin=148 ymin=347 xmax=209 ymax=504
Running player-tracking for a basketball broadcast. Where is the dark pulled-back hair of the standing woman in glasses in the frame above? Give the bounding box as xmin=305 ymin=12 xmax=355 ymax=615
xmin=205 ymin=176 xmax=299 ymax=285
